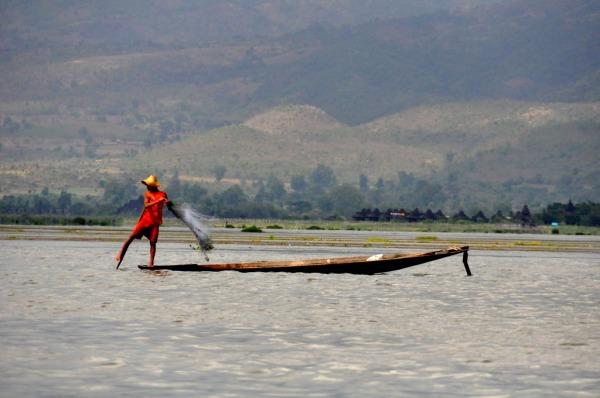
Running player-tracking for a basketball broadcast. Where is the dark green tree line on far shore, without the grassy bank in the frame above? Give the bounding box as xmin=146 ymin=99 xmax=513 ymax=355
xmin=0 ymin=165 xmax=600 ymax=225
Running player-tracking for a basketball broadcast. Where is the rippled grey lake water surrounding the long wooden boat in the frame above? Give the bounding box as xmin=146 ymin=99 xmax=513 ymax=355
xmin=0 ymin=240 xmax=600 ymax=397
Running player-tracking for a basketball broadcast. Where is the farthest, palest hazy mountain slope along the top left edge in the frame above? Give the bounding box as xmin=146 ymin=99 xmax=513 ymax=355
xmin=0 ymin=0 xmax=494 ymax=56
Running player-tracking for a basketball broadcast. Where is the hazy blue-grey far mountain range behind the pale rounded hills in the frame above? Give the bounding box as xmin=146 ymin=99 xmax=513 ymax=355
xmin=0 ymin=0 xmax=600 ymax=125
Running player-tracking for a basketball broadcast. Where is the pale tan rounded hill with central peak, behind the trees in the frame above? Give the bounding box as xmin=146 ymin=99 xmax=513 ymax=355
xmin=140 ymin=107 xmax=435 ymax=181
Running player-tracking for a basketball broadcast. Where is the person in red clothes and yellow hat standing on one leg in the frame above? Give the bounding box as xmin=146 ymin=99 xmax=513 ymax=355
xmin=115 ymin=175 xmax=171 ymax=268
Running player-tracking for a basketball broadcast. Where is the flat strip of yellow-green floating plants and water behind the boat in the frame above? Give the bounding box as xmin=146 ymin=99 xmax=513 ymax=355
xmin=0 ymin=225 xmax=600 ymax=253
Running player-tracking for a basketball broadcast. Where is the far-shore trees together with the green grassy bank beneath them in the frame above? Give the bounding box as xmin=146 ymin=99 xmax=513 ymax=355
xmin=0 ymin=165 xmax=600 ymax=234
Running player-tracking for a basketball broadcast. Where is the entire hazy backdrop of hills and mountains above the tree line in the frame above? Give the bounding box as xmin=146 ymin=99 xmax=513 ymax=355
xmin=0 ymin=0 xmax=600 ymax=210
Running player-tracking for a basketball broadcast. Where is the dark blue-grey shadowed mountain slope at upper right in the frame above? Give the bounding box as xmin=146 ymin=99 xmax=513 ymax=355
xmin=259 ymin=0 xmax=600 ymax=124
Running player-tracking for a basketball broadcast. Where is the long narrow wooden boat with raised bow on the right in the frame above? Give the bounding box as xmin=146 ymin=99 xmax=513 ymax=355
xmin=138 ymin=246 xmax=471 ymax=276
